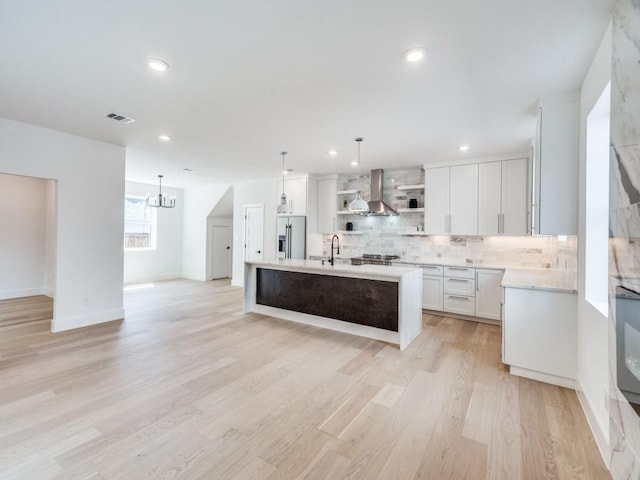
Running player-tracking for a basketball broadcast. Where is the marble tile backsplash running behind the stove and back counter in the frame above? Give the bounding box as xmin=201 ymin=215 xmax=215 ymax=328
xmin=323 ymin=232 xmax=577 ymax=271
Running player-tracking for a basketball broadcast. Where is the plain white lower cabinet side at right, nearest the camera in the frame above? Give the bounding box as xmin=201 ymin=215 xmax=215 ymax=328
xmin=502 ymin=287 xmax=577 ymax=387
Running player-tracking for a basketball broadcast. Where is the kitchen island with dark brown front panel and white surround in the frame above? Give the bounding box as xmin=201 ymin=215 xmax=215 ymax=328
xmin=244 ymin=259 xmax=422 ymax=350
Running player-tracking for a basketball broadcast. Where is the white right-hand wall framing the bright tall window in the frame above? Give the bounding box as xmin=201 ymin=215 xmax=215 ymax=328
xmin=577 ymin=21 xmax=611 ymax=461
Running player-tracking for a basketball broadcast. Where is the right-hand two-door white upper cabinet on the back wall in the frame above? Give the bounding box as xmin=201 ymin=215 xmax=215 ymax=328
xmin=478 ymin=158 xmax=527 ymax=235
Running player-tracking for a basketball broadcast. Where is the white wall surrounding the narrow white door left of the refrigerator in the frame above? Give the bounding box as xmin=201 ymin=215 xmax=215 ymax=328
xmin=231 ymin=178 xmax=278 ymax=287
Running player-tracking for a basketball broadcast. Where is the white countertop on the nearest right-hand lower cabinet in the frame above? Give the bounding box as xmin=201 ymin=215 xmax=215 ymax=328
xmin=502 ymin=268 xmax=578 ymax=293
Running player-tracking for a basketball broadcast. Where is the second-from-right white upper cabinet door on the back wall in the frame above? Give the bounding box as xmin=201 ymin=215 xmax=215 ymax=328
xmin=478 ymin=162 xmax=502 ymax=235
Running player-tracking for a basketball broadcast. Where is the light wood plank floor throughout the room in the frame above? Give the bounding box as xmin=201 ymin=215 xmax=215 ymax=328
xmin=0 ymin=280 xmax=610 ymax=480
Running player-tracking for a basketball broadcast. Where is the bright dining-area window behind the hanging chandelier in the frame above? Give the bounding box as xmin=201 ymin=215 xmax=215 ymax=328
xmin=124 ymin=195 xmax=156 ymax=250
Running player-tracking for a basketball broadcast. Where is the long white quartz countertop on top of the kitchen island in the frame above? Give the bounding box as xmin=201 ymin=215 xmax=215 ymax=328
xmin=245 ymin=259 xmax=417 ymax=278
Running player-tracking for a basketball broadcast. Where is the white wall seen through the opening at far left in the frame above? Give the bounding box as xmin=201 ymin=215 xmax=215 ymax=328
xmin=0 ymin=174 xmax=49 ymax=299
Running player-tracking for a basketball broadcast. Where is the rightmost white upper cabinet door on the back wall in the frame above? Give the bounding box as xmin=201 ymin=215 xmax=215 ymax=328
xmin=501 ymin=158 xmax=528 ymax=235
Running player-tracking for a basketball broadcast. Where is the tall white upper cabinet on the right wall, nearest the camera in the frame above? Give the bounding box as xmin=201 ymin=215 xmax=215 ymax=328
xmin=532 ymin=92 xmax=579 ymax=235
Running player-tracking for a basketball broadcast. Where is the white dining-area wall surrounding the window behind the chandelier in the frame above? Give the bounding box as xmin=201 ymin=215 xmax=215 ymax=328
xmin=124 ymin=182 xmax=184 ymax=284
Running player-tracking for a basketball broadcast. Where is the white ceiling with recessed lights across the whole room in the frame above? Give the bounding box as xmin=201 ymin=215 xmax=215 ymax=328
xmin=0 ymin=0 xmax=611 ymax=187
